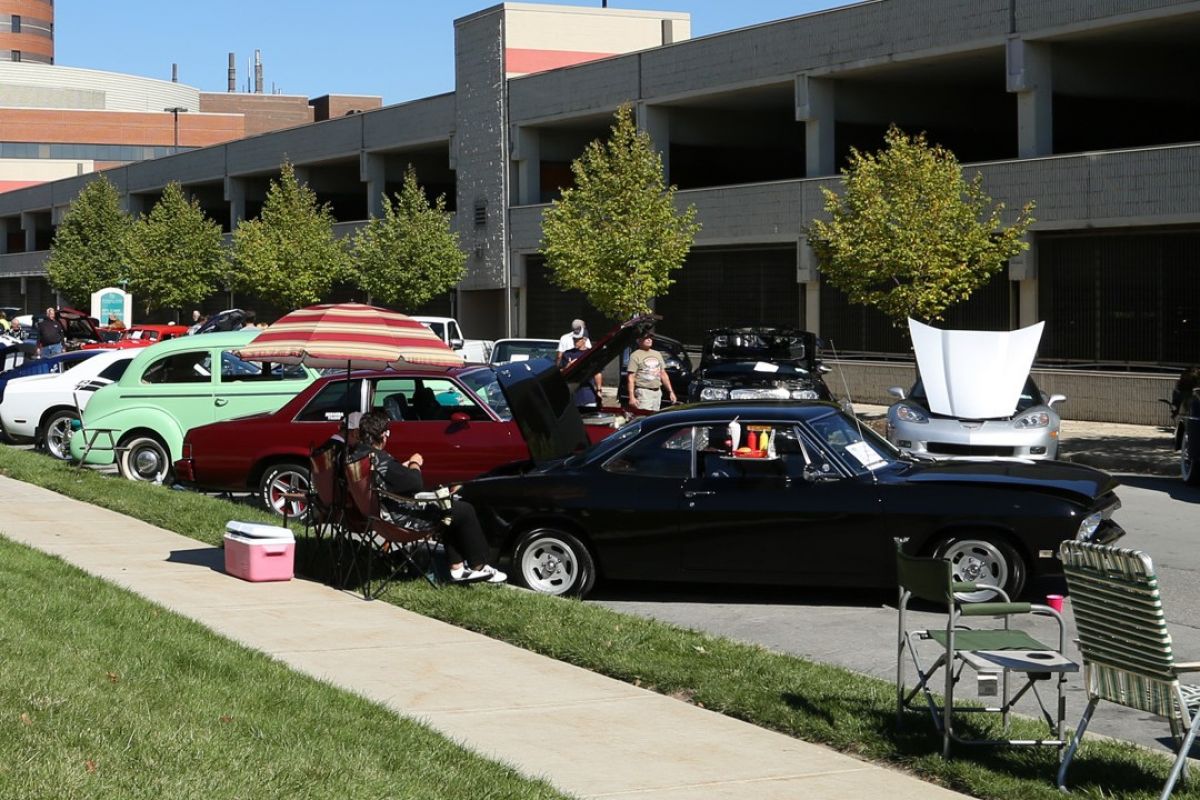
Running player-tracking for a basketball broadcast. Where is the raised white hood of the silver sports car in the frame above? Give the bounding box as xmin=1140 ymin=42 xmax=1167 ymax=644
xmin=908 ymin=319 xmax=1044 ymax=420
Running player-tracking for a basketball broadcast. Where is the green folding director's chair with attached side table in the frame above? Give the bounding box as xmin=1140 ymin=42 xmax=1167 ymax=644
xmin=896 ymin=548 xmax=1079 ymax=758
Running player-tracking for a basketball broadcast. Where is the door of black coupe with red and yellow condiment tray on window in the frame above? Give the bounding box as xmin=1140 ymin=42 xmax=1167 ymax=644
xmin=679 ymin=420 xmax=883 ymax=585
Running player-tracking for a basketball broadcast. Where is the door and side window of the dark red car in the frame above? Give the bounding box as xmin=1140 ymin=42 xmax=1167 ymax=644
xmin=370 ymin=375 xmax=518 ymax=487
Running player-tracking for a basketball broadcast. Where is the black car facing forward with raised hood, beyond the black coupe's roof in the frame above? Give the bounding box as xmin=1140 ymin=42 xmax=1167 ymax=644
xmin=688 ymin=327 xmax=833 ymax=402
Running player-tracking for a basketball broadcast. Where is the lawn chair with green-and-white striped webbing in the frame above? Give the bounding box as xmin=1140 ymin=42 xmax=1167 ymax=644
xmin=1058 ymin=541 xmax=1200 ymax=800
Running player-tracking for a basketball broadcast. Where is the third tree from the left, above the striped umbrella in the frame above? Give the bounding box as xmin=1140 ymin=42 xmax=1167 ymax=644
xmin=229 ymin=162 xmax=350 ymax=308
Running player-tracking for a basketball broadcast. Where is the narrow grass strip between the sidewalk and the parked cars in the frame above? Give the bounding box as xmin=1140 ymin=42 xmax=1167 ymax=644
xmin=0 ymin=447 xmax=1200 ymax=800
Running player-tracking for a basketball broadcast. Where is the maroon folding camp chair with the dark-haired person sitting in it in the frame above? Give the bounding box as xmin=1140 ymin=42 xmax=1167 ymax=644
xmin=346 ymin=456 xmax=450 ymax=600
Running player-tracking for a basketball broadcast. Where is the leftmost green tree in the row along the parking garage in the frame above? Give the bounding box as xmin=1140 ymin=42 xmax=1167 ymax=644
xmin=46 ymin=175 xmax=133 ymax=305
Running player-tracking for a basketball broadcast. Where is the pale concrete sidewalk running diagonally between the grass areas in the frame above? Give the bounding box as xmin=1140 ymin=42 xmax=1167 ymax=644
xmin=0 ymin=477 xmax=964 ymax=800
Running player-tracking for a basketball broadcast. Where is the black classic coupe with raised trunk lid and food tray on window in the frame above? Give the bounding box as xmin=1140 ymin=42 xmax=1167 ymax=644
xmin=462 ymin=363 xmax=1124 ymax=600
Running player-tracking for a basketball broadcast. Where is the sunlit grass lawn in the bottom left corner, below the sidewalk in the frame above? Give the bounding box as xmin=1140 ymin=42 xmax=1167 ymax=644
xmin=0 ymin=537 xmax=563 ymax=800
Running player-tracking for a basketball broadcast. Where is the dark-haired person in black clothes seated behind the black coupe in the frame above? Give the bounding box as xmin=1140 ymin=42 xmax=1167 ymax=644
xmin=352 ymin=410 xmax=508 ymax=583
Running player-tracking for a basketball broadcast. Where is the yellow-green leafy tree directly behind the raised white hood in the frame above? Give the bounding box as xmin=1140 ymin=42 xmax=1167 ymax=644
xmin=808 ymin=126 xmax=1033 ymax=325
